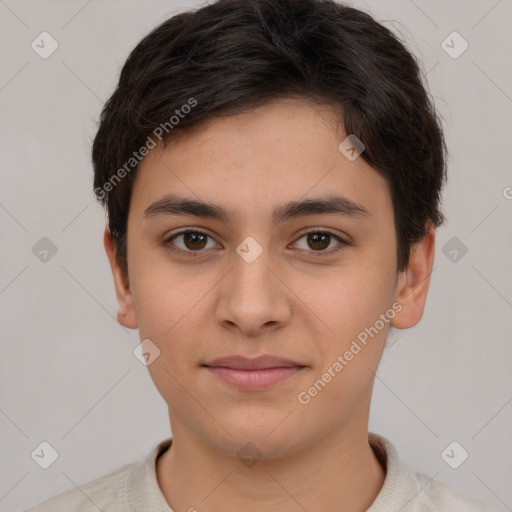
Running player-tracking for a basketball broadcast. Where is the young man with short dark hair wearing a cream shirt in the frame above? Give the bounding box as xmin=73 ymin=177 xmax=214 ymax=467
xmin=27 ymin=0 xmax=492 ymax=512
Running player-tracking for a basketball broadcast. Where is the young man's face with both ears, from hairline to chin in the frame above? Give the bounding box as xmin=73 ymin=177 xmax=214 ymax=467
xmin=105 ymin=99 xmax=433 ymax=458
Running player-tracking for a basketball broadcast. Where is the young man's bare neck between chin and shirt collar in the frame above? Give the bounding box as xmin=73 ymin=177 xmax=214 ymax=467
xmin=157 ymin=420 xmax=386 ymax=512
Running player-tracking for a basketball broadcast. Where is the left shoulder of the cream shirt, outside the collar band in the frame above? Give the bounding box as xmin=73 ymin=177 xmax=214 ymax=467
xmin=25 ymin=462 xmax=137 ymax=512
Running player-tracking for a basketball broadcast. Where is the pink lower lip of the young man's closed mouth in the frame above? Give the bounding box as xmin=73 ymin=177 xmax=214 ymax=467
xmin=207 ymin=366 xmax=303 ymax=391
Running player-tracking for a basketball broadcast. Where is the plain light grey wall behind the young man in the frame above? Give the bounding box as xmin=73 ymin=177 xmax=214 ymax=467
xmin=0 ymin=0 xmax=512 ymax=511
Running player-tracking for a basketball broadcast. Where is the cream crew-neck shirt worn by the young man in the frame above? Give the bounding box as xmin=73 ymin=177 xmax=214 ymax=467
xmin=25 ymin=432 xmax=492 ymax=512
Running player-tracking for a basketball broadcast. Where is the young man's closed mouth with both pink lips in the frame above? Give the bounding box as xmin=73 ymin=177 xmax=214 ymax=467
xmin=201 ymin=355 xmax=307 ymax=391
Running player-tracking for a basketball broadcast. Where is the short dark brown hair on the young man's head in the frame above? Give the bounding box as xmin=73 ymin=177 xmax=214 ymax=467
xmin=92 ymin=0 xmax=446 ymax=276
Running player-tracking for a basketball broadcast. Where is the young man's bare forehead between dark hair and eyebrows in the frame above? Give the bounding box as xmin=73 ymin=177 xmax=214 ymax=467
xmin=130 ymin=99 xmax=392 ymax=227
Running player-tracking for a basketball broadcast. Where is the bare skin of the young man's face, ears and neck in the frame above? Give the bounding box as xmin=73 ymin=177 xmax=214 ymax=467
xmin=104 ymin=99 xmax=435 ymax=512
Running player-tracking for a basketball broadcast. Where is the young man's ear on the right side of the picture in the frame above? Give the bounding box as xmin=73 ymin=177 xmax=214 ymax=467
xmin=390 ymin=225 xmax=436 ymax=329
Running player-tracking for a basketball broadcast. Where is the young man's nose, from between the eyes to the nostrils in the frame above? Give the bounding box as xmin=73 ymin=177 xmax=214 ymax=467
xmin=216 ymin=247 xmax=292 ymax=337
